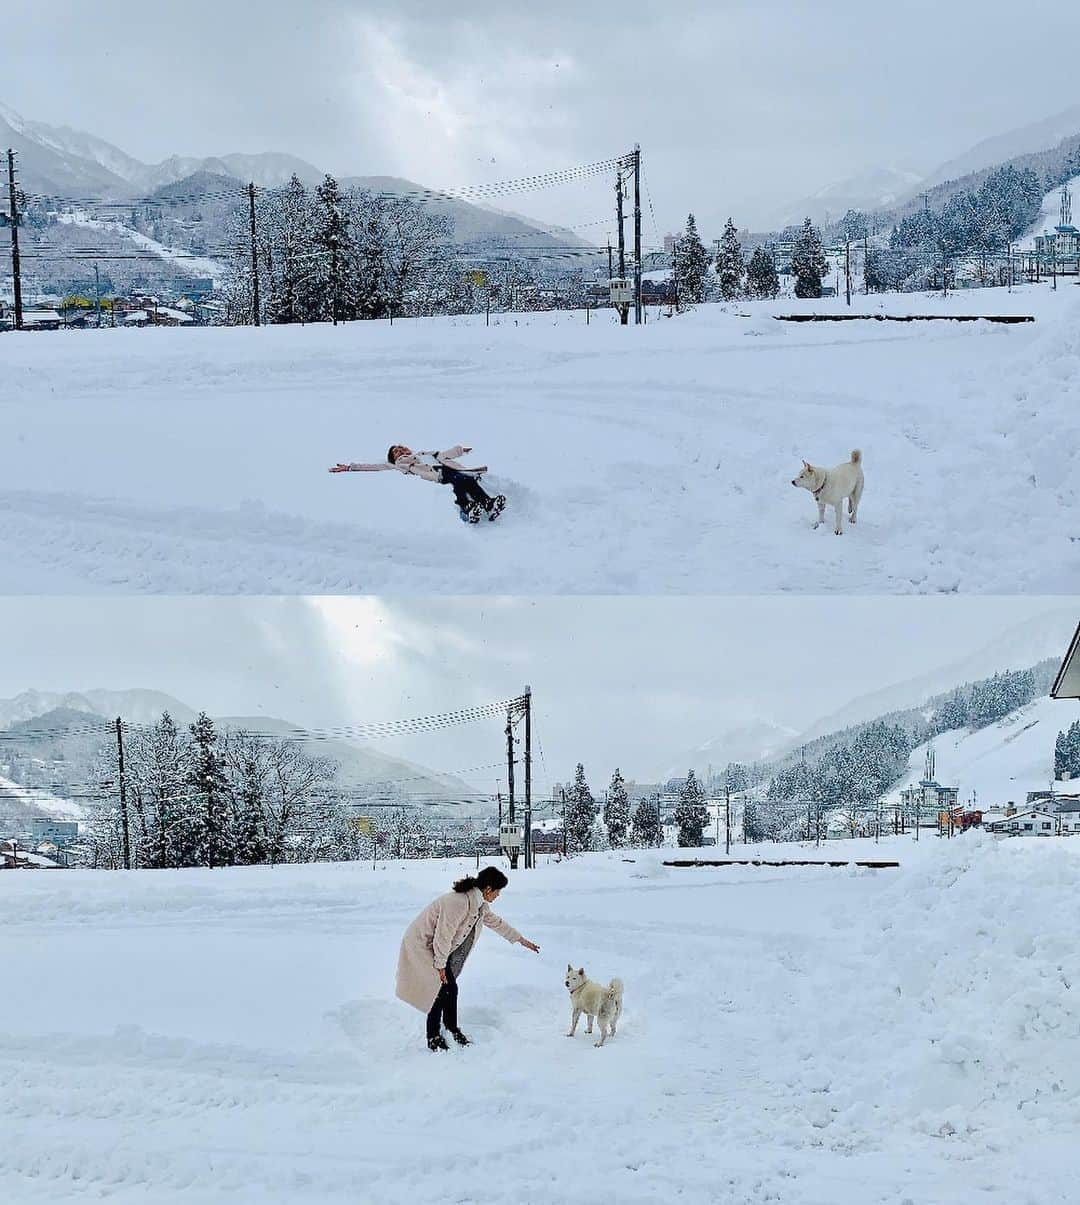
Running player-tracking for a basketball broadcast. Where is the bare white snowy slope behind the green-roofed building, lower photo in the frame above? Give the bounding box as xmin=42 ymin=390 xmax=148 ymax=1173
xmin=890 ymin=698 xmax=1080 ymax=809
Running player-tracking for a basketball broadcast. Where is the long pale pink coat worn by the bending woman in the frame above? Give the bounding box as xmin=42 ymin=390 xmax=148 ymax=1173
xmin=398 ymin=887 xmax=521 ymax=1012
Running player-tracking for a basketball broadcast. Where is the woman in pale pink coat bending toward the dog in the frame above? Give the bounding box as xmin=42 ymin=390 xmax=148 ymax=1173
xmin=398 ymin=866 xmax=540 ymax=1051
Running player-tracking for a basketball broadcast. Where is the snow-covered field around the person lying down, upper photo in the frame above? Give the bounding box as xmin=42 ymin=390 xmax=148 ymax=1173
xmin=0 ymin=286 xmax=1080 ymax=594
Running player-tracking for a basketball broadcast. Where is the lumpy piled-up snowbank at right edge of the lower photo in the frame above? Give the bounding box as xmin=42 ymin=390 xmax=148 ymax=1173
xmin=849 ymin=833 xmax=1080 ymax=1144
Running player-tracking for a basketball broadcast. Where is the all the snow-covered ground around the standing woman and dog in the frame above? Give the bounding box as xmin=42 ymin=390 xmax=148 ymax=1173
xmin=0 ymin=834 xmax=1080 ymax=1205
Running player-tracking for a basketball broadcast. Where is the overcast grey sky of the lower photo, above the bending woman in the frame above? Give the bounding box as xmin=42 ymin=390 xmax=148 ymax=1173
xmin=0 ymin=596 xmax=1080 ymax=790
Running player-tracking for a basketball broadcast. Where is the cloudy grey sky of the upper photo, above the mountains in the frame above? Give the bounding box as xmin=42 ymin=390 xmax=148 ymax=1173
xmin=0 ymin=0 xmax=1080 ymax=232
